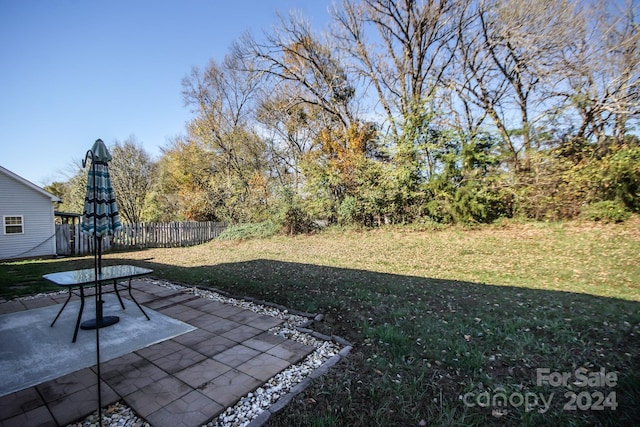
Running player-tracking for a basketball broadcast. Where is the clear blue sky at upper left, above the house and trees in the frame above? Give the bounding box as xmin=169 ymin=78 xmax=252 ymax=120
xmin=0 ymin=0 xmax=331 ymax=186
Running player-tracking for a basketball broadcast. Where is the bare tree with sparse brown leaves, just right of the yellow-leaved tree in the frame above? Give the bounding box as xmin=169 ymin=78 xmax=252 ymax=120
xmin=233 ymin=13 xmax=358 ymax=197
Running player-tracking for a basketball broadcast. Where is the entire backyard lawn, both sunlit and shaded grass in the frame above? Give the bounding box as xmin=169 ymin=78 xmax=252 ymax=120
xmin=0 ymin=218 xmax=640 ymax=426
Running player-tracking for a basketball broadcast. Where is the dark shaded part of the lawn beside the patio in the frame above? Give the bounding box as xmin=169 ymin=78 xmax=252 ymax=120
xmin=0 ymin=258 xmax=640 ymax=426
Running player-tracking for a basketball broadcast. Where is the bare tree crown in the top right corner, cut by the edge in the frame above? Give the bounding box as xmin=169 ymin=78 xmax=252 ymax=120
xmin=558 ymin=1 xmax=640 ymax=148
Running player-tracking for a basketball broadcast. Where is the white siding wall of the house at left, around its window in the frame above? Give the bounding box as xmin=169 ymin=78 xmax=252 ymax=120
xmin=0 ymin=173 xmax=56 ymax=259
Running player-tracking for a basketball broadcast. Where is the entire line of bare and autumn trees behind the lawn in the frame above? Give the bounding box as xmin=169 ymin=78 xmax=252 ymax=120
xmin=49 ymin=0 xmax=640 ymax=231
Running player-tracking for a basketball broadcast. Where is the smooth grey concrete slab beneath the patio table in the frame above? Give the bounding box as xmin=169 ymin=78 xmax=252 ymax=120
xmin=0 ymin=295 xmax=195 ymax=396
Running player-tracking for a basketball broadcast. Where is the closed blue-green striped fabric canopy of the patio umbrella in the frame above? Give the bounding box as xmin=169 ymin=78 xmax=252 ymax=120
xmin=80 ymin=139 xmax=122 ymax=237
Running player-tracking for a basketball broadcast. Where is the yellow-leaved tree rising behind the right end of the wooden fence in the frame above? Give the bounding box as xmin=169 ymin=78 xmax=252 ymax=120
xmin=163 ymin=57 xmax=270 ymax=222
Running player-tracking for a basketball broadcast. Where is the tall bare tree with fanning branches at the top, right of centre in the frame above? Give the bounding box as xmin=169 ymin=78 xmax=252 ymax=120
xmin=333 ymin=0 xmax=464 ymax=141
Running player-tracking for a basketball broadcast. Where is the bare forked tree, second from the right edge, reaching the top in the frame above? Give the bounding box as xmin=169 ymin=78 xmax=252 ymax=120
xmin=454 ymin=0 xmax=575 ymax=170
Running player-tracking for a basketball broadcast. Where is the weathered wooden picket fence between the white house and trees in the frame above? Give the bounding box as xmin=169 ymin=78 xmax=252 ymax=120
xmin=56 ymin=221 xmax=225 ymax=255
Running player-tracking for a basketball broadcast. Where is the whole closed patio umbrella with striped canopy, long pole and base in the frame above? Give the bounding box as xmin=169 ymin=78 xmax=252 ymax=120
xmin=80 ymin=139 xmax=122 ymax=426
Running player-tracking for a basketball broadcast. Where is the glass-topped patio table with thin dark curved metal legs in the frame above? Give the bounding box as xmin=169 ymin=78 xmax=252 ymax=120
xmin=42 ymin=265 xmax=153 ymax=342
